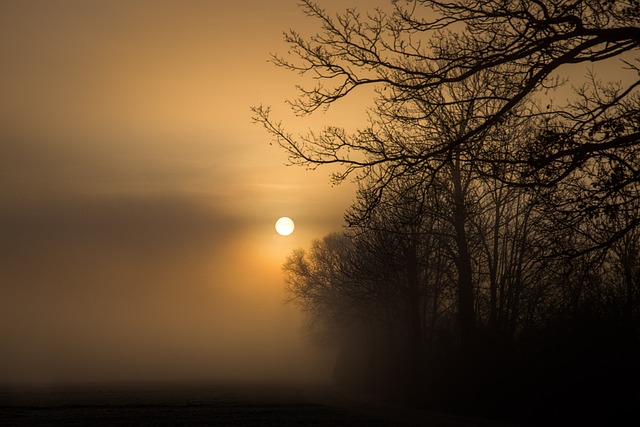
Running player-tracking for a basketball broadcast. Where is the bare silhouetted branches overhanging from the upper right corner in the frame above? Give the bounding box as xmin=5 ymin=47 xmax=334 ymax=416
xmin=254 ymin=0 xmax=640 ymax=247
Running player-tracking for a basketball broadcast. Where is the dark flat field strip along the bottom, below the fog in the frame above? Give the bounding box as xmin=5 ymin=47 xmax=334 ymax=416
xmin=0 ymin=383 xmax=510 ymax=427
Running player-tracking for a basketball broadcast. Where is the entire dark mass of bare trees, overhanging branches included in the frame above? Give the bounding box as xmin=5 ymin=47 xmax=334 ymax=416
xmin=253 ymin=0 xmax=640 ymax=424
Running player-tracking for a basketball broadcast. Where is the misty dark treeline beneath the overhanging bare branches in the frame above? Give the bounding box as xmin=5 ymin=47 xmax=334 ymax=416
xmin=284 ymin=163 xmax=640 ymax=424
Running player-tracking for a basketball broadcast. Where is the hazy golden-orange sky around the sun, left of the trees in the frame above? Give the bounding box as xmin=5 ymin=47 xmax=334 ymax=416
xmin=0 ymin=0 xmax=376 ymax=383
